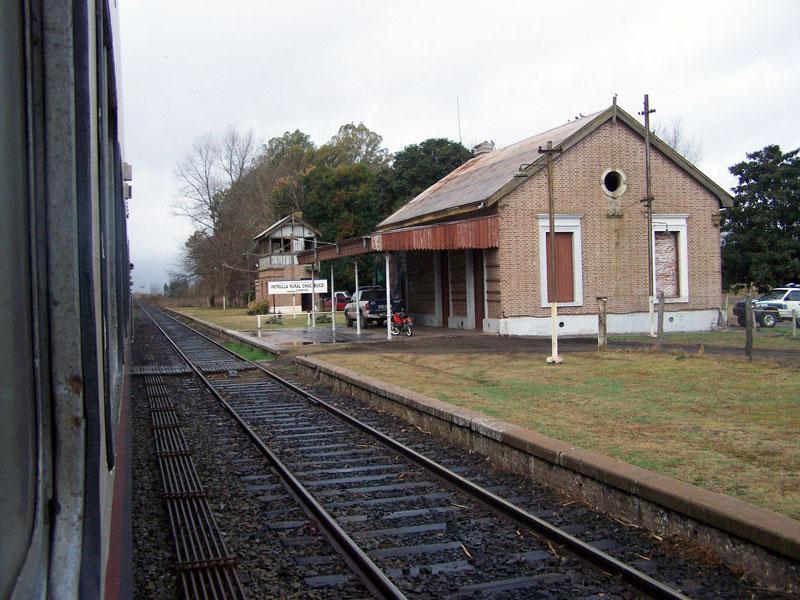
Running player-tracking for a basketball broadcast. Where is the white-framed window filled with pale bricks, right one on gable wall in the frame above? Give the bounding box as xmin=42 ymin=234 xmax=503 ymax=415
xmin=651 ymin=214 xmax=689 ymax=302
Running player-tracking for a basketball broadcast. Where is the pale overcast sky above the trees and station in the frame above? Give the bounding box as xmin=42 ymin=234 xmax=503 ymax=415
xmin=116 ymin=0 xmax=800 ymax=291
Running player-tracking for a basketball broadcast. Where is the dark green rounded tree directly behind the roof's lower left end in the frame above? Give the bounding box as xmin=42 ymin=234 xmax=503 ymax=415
xmin=392 ymin=138 xmax=472 ymax=207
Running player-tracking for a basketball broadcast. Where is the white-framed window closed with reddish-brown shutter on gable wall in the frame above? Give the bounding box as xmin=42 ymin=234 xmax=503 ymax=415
xmin=537 ymin=215 xmax=583 ymax=307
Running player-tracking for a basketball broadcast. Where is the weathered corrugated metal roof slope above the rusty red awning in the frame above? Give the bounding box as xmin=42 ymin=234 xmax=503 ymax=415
xmin=377 ymin=111 xmax=602 ymax=229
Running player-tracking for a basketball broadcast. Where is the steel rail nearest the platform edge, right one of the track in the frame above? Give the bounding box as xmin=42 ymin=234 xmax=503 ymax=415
xmin=151 ymin=312 xmax=688 ymax=600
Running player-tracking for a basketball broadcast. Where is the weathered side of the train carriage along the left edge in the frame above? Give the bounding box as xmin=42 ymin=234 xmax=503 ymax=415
xmin=0 ymin=0 xmax=131 ymax=599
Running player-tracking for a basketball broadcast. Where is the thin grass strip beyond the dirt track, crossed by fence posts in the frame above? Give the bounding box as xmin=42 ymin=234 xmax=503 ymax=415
xmin=608 ymin=323 xmax=800 ymax=350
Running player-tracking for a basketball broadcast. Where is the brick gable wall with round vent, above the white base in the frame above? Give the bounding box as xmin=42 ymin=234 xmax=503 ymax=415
xmin=496 ymin=122 xmax=721 ymax=318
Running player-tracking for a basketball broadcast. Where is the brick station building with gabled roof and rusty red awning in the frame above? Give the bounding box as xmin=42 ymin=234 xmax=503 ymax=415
xmin=300 ymin=103 xmax=732 ymax=335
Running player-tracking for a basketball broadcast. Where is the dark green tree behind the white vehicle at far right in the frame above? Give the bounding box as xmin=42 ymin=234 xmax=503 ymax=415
xmin=722 ymin=146 xmax=800 ymax=289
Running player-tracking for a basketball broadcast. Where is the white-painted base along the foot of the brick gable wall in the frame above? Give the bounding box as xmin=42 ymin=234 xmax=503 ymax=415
xmin=484 ymin=309 xmax=718 ymax=336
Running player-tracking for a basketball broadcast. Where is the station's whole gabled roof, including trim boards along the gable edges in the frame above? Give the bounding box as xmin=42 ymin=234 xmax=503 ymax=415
xmin=376 ymin=104 xmax=733 ymax=231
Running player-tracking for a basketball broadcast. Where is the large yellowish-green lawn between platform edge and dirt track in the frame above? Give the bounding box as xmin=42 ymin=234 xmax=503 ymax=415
xmin=318 ymin=351 xmax=800 ymax=519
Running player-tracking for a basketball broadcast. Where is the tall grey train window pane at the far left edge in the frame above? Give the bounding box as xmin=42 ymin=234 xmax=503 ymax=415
xmin=0 ymin=2 xmax=38 ymax=598
